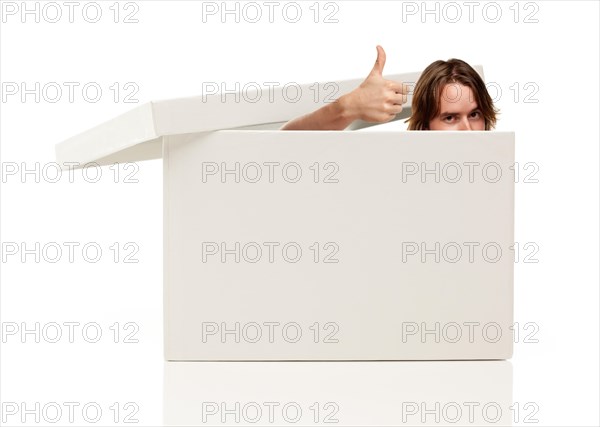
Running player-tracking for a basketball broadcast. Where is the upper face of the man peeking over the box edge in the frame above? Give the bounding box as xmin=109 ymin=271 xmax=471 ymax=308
xmin=429 ymin=83 xmax=485 ymax=130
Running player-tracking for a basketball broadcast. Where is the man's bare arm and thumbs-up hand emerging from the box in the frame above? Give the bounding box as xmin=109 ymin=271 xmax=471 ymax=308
xmin=280 ymin=46 xmax=408 ymax=130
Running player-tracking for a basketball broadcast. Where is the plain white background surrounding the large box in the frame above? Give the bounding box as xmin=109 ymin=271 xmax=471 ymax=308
xmin=0 ymin=1 xmax=600 ymax=425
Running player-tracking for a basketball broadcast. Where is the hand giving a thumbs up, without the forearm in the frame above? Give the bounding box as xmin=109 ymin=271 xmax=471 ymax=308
xmin=345 ymin=45 xmax=409 ymax=123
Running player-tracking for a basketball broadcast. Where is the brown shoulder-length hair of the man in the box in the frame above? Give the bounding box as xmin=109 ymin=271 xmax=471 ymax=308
xmin=405 ymin=58 xmax=498 ymax=130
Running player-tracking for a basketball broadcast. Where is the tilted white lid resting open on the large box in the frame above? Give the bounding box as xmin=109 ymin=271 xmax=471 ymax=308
xmin=56 ymin=66 xmax=483 ymax=167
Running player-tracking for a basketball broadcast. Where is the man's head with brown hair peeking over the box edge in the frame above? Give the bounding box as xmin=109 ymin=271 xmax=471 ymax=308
xmin=408 ymin=59 xmax=498 ymax=130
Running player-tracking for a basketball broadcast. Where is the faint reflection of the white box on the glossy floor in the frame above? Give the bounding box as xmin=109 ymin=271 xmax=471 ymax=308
xmin=163 ymin=360 xmax=510 ymax=426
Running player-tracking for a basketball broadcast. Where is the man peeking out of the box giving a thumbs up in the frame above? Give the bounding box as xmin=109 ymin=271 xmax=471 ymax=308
xmin=281 ymin=46 xmax=498 ymax=130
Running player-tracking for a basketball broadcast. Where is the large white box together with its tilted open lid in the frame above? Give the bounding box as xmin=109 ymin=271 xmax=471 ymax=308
xmin=57 ymin=67 xmax=514 ymax=360
